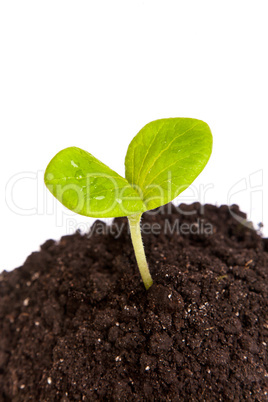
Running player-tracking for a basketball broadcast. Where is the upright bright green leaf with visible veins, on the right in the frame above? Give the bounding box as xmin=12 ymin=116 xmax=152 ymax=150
xmin=125 ymin=118 xmax=212 ymax=210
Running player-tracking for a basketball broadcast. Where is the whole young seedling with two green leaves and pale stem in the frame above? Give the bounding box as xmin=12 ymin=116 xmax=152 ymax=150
xmin=45 ymin=118 xmax=212 ymax=289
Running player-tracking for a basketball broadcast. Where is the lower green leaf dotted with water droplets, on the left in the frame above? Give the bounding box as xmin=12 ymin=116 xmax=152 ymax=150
xmin=45 ymin=147 xmax=146 ymax=218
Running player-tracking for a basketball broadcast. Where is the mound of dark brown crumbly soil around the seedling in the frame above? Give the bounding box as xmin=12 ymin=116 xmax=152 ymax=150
xmin=0 ymin=203 xmax=268 ymax=401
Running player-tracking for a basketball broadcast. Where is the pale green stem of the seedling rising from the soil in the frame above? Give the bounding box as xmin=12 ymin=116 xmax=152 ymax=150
xmin=128 ymin=214 xmax=153 ymax=290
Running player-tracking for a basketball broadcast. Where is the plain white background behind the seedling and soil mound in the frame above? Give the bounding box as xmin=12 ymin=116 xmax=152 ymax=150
xmin=0 ymin=0 xmax=268 ymax=270
